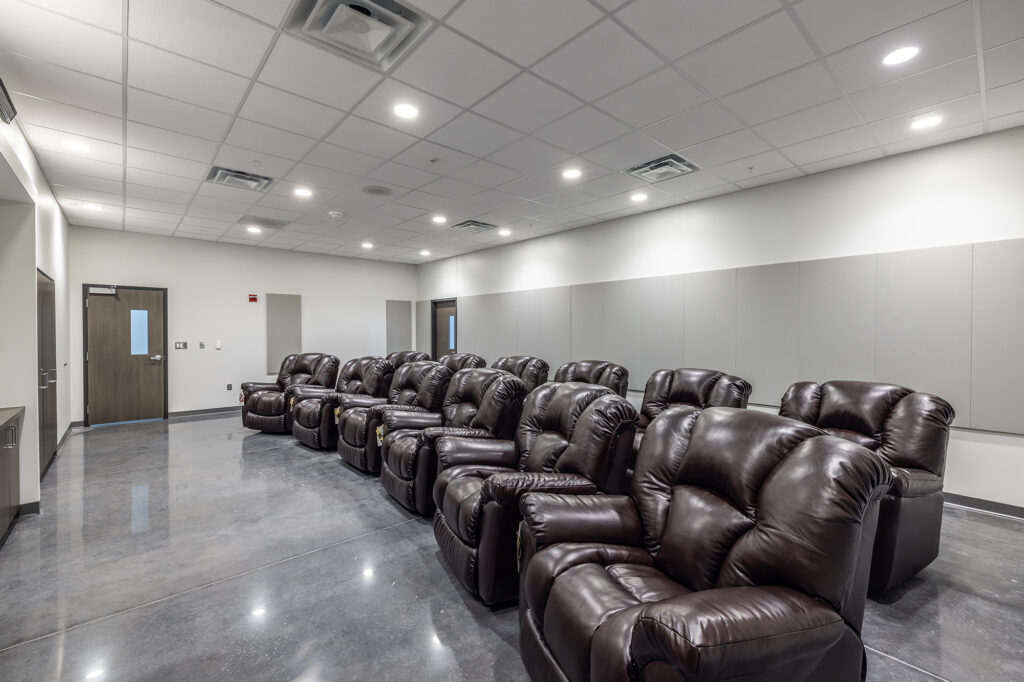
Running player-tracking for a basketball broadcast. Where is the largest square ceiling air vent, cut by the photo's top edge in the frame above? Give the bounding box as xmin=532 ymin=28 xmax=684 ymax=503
xmin=288 ymin=0 xmax=431 ymax=71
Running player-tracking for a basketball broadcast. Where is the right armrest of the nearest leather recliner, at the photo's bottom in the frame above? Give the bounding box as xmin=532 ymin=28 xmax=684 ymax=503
xmin=630 ymin=586 xmax=849 ymax=680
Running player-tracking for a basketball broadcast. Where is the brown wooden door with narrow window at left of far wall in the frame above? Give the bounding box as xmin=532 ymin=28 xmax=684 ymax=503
xmin=85 ymin=285 xmax=167 ymax=426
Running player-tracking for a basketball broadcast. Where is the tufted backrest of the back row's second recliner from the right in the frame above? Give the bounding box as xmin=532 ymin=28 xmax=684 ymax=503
xmin=640 ymin=369 xmax=751 ymax=429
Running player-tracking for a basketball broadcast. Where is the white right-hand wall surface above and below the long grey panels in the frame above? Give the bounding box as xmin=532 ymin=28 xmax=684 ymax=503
xmin=419 ymin=128 xmax=1024 ymax=506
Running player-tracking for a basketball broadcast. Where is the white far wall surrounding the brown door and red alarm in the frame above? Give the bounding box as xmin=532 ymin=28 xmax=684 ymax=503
xmin=71 ymin=226 xmax=416 ymax=421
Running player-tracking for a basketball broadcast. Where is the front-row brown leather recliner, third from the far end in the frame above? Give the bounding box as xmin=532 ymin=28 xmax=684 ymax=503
xmin=338 ymin=360 xmax=452 ymax=474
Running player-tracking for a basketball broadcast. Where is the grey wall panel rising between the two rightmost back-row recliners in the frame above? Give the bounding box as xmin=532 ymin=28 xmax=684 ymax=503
xmin=735 ymin=263 xmax=800 ymax=406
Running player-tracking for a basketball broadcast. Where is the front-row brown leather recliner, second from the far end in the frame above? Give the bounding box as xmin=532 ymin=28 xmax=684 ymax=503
xmin=285 ymin=355 xmax=394 ymax=450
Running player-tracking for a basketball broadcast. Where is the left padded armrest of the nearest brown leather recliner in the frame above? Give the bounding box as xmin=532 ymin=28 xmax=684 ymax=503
xmin=519 ymin=493 xmax=643 ymax=550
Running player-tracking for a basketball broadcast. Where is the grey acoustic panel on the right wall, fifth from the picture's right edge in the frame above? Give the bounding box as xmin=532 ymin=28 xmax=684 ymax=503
xmin=679 ymin=269 xmax=736 ymax=373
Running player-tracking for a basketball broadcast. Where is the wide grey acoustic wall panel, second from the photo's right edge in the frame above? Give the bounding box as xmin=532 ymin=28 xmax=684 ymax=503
xmin=874 ymin=245 xmax=970 ymax=426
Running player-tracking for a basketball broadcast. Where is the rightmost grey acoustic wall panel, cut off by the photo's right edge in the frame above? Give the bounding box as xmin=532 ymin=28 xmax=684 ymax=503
xmin=971 ymin=240 xmax=1024 ymax=433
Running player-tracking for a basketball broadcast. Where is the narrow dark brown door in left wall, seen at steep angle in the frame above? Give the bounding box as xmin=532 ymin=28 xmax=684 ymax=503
xmin=36 ymin=270 xmax=57 ymax=478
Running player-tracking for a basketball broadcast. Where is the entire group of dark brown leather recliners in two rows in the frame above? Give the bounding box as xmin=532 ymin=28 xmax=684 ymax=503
xmin=243 ymin=351 xmax=953 ymax=681
